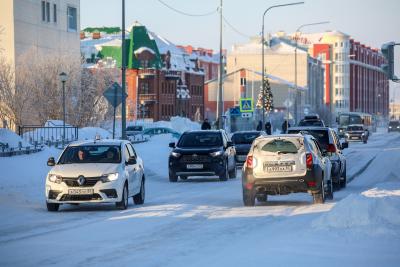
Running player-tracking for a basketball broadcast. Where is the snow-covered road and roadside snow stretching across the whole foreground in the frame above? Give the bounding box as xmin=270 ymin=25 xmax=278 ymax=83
xmin=0 ymin=133 xmax=400 ymax=266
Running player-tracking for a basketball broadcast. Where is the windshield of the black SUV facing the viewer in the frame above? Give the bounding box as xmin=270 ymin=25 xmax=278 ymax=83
xmin=178 ymin=133 xmax=222 ymax=147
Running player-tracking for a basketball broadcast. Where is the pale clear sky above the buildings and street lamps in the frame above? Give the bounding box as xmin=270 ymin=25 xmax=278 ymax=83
xmin=80 ymin=0 xmax=400 ymax=99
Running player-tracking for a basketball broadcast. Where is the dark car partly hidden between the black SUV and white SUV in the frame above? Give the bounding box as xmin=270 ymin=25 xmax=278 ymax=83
xmin=231 ymin=131 xmax=264 ymax=166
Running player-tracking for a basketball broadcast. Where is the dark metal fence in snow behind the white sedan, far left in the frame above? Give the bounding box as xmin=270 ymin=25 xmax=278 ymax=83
xmin=18 ymin=125 xmax=78 ymax=146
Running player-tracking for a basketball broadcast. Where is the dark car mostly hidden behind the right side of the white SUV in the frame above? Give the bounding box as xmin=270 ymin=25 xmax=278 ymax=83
xmin=288 ymin=127 xmax=349 ymax=189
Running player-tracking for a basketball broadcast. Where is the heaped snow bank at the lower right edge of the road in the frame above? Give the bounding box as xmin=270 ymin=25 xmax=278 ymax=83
xmin=312 ymin=181 xmax=400 ymax=235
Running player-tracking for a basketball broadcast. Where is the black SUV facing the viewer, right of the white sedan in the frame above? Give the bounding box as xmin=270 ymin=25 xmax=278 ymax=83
xmin=168 ymin=130 xmax=236 ymax=182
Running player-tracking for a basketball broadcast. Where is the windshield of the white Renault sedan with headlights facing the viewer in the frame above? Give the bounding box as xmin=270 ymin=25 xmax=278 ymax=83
xmin=58 ymin=145 xmax=121 ymax=164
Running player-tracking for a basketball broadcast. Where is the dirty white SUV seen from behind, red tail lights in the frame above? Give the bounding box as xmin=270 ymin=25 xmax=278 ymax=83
xmin=242 ymin=134 xmax=333 ymax=206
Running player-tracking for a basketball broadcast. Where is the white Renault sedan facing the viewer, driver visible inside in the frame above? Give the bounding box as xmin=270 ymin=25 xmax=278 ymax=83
xmin=46 ymin=140 xmax=145 ymax=211
